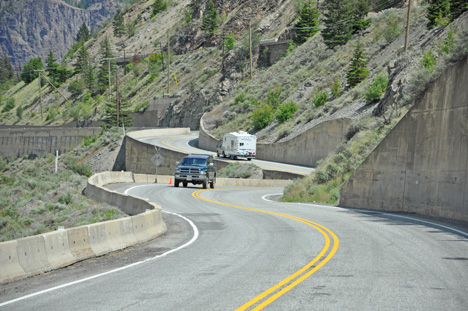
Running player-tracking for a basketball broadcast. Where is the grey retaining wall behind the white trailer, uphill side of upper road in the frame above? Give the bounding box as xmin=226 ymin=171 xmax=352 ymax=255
xmin=198 ymin=113 xmax=351 ymax=167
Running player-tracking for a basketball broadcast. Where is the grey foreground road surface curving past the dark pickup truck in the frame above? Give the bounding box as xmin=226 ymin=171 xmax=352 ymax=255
xmin=0 ymin=133 xmax=468 ymax=311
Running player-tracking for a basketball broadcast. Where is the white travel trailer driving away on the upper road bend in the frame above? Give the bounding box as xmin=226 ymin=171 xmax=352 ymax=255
xmin=216 ymin=132 xmax=257 ymax=161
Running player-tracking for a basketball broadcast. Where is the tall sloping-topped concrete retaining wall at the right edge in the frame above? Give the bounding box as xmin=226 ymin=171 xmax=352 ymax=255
xmin=340 ymin=54 xmax=468 ymax=221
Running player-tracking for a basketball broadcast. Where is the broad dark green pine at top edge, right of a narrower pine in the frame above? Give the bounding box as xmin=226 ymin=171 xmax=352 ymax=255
xmin=322 ymin=0 xmax=355 ymax=48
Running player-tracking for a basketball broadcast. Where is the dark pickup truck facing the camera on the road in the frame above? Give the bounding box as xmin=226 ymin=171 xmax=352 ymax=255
xmin=174 ymin=154 xmax=217 ymax=189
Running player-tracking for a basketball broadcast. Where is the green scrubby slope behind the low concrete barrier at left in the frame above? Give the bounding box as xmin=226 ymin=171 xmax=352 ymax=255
xmin=0 ymin=130 xmax=127 ymax=242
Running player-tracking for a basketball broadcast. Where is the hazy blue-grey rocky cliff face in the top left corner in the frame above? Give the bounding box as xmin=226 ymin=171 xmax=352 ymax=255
xmin=0 ymin=0 xmax=122 ymax=67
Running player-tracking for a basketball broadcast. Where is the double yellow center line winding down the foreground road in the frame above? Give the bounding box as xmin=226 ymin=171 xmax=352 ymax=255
xmin=192 ymin=190 xmax=339 ymax=311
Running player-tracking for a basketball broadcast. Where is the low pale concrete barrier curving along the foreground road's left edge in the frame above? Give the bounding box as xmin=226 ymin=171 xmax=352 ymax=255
xmin=0 ymin=172 xmax=166 ymax=284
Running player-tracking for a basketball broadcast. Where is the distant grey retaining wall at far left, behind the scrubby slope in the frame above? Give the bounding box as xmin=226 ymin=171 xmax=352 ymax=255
xmin=0 ymin=127 xmax=102 ymax=158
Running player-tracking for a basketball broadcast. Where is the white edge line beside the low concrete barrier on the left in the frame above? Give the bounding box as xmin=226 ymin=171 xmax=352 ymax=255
xmin=0 ymin=187 xmax=199 ymax=307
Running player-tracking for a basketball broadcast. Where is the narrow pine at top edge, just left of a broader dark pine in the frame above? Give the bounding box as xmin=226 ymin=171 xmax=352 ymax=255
xmin=293 ymin=0 xmax=320 ymax=44
